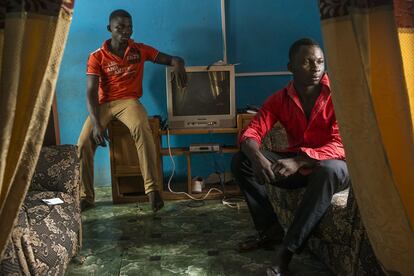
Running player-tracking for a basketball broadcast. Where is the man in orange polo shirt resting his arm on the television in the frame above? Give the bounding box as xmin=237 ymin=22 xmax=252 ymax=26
xmin=78 ymin=10 xmax=187 ymax=212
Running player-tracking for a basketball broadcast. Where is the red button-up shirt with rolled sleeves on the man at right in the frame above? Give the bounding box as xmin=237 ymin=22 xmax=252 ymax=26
xmin=239 ymin=74 xmax=345 ymax=160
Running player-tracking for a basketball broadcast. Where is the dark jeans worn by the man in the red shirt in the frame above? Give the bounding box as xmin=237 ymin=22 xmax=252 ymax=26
xmin=231 ymin=150 xmax=349 ymax=252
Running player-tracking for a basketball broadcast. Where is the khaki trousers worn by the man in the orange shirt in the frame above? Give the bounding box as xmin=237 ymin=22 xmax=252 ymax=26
xmin=78 ymin=99 xmax=159 ymax=203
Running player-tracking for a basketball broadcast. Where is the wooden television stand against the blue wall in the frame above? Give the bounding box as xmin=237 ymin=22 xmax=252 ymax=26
xmin=108 ymin=114 xmax=254 ymax=203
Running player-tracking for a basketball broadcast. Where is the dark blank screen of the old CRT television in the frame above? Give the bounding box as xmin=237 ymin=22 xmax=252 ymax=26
xmin=172 ymin=71 xmax=230 ymax=116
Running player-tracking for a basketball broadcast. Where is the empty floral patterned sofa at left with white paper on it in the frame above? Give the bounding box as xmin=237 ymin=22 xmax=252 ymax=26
xmin=0 ymin=145 xmax=81 ymax=275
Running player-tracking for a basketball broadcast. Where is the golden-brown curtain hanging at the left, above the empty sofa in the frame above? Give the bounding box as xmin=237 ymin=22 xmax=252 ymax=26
xmin=0 ymin=0 xmax=74 ymax=256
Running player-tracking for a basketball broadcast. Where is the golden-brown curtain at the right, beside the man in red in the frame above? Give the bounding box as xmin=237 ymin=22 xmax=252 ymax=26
xmin=319 ymin=0 xmax=414 ymax=275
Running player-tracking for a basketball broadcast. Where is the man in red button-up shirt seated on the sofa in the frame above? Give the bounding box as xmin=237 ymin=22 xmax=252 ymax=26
xmin=232 ymin=38 xmax=349 ymax=275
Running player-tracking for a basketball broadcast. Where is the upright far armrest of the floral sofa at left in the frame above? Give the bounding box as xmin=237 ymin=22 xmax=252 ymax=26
xmin=29 ymin=145 xmax=80 ymax=198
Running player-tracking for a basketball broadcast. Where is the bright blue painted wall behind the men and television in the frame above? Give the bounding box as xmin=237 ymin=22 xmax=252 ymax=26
xmin=57 ymin=0 xmax=322 ymax=185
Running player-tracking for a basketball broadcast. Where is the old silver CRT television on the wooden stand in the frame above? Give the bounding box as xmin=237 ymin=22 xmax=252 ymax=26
xmin=166 ymin=65 xmax=236 ymax=129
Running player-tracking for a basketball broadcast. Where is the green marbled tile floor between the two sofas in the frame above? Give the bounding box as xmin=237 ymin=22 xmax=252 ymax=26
xmin=66 ymin=187 xmax=331 ymax=276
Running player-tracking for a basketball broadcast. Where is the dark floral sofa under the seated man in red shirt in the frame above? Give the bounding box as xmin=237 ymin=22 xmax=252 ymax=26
xmin=263 ymin=125 xmax=384 ymax=275
